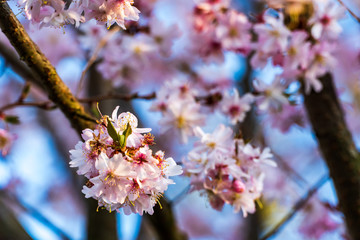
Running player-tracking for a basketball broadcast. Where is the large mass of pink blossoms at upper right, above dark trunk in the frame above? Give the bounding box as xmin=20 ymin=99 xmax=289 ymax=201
xmin=193 ymin=0 xmax=344 ymax=93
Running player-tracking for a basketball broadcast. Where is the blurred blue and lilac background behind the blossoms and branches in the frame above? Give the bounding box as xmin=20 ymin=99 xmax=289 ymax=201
xmin=0 ymin=0 xmax=360 ymax=240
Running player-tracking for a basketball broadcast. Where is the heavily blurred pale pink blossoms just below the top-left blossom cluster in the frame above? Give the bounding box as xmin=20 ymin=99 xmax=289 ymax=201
xmin=95 ymin=17 xmax=180 ymax=87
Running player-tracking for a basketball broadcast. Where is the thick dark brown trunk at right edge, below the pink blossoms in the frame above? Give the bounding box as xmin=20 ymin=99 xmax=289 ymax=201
xmin=304 ymin=74 xmax=360 ymax=240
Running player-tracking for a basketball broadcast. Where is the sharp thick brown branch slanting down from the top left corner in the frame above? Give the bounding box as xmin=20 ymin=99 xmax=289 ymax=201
xmin=0 ymin=1 xmax=93 ymax=133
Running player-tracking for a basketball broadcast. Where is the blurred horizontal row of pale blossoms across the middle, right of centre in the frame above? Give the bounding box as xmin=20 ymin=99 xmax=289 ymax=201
xmin=150 ymin=78 xmax=305 ymax=143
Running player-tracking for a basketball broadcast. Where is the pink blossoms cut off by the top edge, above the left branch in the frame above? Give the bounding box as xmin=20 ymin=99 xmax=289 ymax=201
xmin=19 ymin=0 xmax=140 ymax=29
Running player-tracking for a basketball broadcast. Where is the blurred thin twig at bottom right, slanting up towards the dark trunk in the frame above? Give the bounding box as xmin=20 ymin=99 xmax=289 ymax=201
xmin=260 ymin=174 xmax=330 ymax=240
